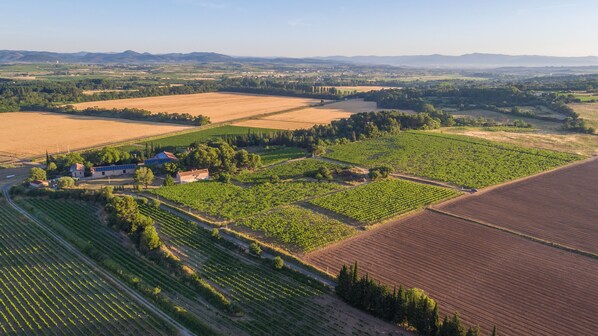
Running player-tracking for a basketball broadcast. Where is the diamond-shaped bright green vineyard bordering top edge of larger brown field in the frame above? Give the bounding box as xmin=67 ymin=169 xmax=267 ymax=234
xmin=309 ymin=179 xmax=459 ymax=224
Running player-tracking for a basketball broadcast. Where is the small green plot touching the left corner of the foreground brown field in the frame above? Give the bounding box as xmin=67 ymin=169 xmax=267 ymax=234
xmin=236 ymin=206 xmax=356 ymax=252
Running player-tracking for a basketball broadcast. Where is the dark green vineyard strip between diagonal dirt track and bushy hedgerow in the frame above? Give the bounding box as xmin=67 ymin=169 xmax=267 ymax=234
xmin=22 ymin=198 xmax=225 ymax=335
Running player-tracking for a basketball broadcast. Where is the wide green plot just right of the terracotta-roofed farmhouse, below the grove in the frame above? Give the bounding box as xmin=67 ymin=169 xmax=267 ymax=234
xmin=152 ymin=182 xmax=342 ymax=219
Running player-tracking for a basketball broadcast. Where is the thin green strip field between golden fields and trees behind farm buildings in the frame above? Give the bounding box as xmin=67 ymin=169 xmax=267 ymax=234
xmin=141 ymin=125 xmax=278 ymax=147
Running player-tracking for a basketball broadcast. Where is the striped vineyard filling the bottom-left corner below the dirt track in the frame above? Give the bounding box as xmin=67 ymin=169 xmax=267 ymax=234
xmin=0 ymin=201 xmax=174 ymax=335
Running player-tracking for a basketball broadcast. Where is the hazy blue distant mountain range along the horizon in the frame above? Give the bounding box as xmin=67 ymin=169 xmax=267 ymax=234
xmin=0 ymin=50 xmax=598 ymax=68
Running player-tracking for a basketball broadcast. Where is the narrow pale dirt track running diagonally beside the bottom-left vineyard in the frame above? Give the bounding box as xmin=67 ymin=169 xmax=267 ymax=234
xmin=2 ymin=185 xmax=194 ymax=336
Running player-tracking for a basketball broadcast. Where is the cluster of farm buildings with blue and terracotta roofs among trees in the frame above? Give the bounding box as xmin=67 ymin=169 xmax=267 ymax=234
xmin=69 ymin=152 xmax=210 ymax=183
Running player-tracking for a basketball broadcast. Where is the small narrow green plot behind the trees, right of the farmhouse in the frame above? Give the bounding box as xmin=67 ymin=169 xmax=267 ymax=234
xmin=235 ymin=159 xmax=343 ymax=182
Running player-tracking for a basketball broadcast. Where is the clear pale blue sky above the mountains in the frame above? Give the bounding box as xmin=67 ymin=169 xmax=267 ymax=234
xmin=0 ymin=0 xmax=598 ymax=57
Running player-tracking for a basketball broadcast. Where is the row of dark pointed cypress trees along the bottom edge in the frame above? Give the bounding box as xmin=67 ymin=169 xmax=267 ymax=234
xmin=336 ymin=262 xmax=496 ymax=336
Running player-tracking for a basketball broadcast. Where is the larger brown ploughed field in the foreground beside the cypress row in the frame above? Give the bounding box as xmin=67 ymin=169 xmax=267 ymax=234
xmin=305 ymin=211 xmax=598 ymax=335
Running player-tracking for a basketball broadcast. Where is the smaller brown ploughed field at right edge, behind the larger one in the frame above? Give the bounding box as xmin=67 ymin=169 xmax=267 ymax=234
xmin=437 ymin=160 xmax=598 ymax=253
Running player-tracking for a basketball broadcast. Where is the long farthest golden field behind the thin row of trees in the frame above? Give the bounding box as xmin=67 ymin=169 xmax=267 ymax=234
xmin=75 ymin=92 xmax=320 ymax=123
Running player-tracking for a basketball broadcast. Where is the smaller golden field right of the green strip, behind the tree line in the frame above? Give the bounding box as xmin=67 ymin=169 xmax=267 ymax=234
xmin=234 ymin=99 xmax=380 ymax=129
